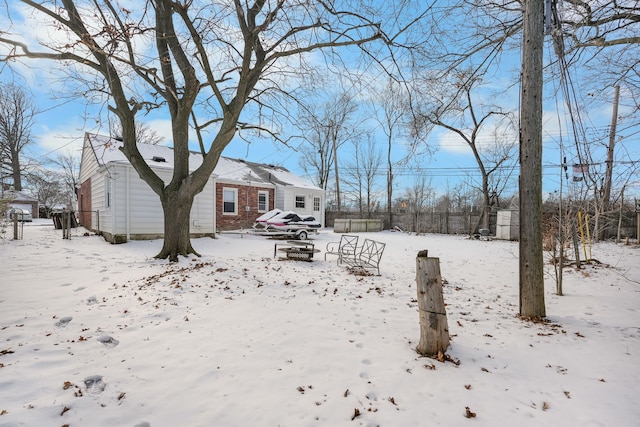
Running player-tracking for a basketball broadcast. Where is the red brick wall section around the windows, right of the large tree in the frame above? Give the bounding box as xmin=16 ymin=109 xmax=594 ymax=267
xmin=216 ymin=182 xmax=275 ymax=231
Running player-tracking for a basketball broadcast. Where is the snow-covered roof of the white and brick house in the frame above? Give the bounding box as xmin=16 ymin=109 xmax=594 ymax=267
xmin=86 ymin=134 xmax=321 ymax=190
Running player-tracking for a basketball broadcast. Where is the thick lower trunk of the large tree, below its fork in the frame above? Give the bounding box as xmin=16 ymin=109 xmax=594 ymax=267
xmin=156 ymin=186 xmax=200 ymax=262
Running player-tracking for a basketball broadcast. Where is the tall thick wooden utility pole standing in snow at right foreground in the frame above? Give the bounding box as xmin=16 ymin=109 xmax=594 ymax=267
xmin=520 ymin=0 xmax=546 ymax=318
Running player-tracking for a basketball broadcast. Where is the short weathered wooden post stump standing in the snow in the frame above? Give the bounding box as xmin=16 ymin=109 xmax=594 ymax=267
xmin=416 ymin=250 xmax=449 ymax=356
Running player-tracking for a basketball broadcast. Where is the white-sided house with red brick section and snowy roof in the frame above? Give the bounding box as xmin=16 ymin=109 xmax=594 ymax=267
xmin=78 ymin=133 xmax=325 ymax=243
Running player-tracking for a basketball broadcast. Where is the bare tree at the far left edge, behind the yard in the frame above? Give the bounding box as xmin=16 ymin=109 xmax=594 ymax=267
xmin=0 ymin=84 xmax=36 ymax=191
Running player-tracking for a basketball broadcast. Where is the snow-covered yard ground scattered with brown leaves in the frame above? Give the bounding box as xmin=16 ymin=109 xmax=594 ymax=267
xmin=0 ymin=220 xmax=640 ymax=427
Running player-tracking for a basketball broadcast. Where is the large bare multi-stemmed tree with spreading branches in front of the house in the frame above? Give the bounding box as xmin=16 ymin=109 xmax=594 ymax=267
xmin=0 ymin=0 xmax=405 ymax=260
